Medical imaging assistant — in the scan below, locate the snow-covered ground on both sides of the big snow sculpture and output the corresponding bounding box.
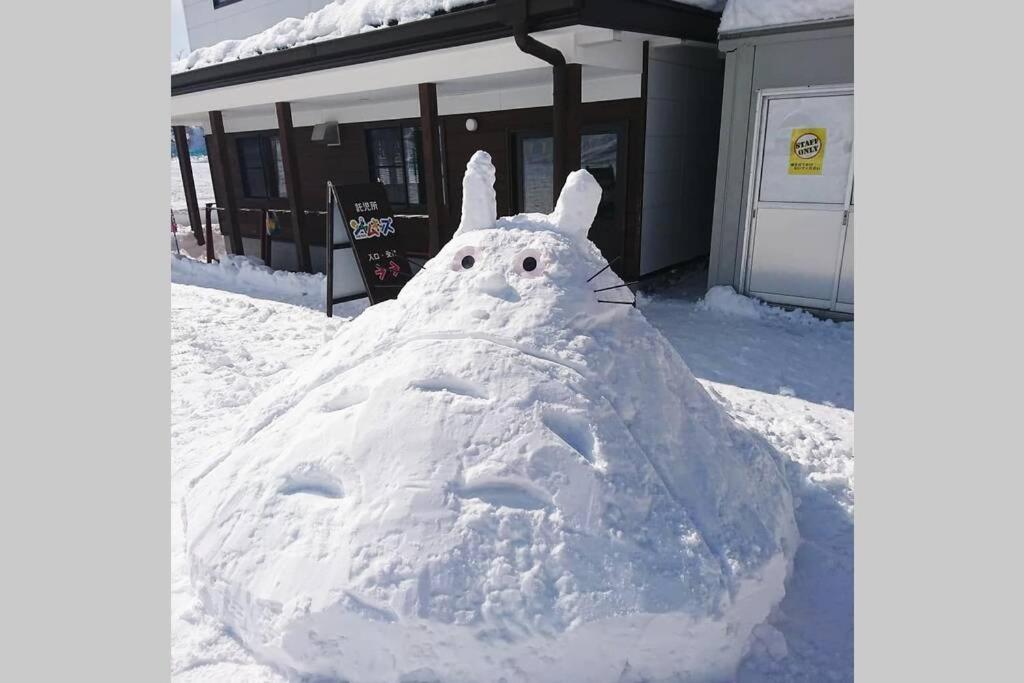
[171,257,854,682]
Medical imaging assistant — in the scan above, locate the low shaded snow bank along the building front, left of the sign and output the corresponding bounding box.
[171,252,326,308]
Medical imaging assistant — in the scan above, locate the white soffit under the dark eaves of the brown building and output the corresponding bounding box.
[171,26,655,118]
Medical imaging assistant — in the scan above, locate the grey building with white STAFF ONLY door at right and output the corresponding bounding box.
[708,6,854,315]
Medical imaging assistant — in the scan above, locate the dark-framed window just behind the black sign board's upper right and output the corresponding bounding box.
[367,126,423,208]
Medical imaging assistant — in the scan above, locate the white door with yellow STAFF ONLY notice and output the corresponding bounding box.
[745,87,853,312]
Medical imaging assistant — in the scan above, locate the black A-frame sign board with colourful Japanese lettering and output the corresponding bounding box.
[325,181,412,316]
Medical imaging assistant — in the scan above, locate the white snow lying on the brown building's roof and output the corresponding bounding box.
[171,0,725,74]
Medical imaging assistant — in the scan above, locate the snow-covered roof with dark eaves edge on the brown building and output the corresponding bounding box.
[171,0,722,96]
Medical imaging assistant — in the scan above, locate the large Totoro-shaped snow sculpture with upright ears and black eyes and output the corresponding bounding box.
[185,153,798,683]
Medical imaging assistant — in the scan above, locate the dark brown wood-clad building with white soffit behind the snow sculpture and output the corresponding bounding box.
[171,0,725,279]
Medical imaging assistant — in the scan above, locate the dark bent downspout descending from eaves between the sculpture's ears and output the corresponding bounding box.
[498,0,570,206]
